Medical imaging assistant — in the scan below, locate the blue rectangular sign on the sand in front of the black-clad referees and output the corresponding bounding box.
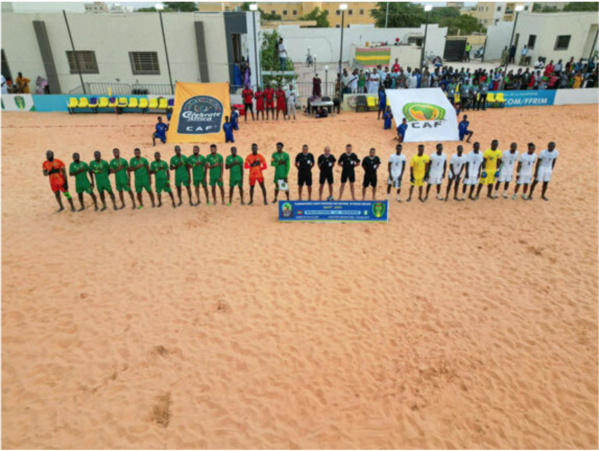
[279,200,389,222]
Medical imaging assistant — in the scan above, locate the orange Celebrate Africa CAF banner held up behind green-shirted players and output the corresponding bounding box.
[166,82,231,143]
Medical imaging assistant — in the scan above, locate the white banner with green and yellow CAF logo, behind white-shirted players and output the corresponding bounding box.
[385,88,460,142]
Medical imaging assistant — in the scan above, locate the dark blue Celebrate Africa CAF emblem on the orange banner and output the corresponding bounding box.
[177,96,224,135]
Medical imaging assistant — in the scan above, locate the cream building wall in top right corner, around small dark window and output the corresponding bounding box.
[514,13,599,62]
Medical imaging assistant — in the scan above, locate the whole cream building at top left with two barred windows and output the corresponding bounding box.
[1,12,260,94]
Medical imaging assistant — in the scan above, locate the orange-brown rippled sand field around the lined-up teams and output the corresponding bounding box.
[2,105,598,449]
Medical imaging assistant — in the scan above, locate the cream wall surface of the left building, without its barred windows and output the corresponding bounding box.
[2,13,248,93]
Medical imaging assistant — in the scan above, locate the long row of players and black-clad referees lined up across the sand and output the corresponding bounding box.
[43,140,558,211]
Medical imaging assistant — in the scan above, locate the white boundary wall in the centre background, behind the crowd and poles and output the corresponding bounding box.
[278,24,447,63]
